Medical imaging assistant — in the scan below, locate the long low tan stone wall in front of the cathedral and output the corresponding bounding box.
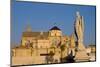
[12,48,67,65]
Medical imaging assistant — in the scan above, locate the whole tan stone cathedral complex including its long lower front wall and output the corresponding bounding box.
[12,26,73,65]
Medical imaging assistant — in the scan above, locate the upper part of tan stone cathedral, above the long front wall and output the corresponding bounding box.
[21,26,69,48]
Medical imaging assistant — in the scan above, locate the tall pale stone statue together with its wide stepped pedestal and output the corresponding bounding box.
[74,12,89,62]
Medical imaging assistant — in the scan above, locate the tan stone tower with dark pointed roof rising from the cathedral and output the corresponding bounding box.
[49,26,62,47]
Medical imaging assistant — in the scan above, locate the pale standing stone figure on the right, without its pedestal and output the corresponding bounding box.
[74,12,85,49]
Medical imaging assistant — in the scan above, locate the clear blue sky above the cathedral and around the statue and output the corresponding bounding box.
[11,1,96,45]
